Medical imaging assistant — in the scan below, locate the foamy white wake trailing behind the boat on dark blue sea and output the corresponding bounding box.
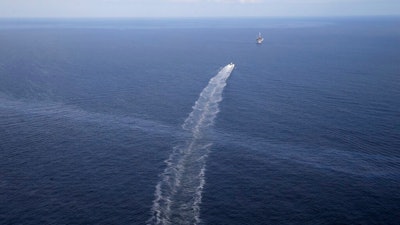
[147,63,235,225]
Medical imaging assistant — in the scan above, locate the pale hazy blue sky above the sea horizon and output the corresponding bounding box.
[0,0,400,17]
